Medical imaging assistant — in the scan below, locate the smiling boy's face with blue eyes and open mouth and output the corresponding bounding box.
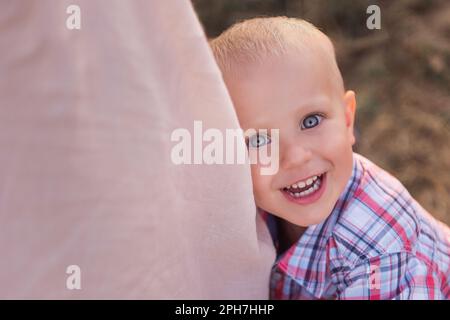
[225,49,355,226]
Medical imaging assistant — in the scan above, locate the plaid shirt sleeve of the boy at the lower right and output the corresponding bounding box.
[336,252,445,300]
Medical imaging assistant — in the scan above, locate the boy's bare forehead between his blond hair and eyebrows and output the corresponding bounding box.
[225,50,340,128]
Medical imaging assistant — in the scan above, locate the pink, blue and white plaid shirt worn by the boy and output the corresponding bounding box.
[261,153,450,300]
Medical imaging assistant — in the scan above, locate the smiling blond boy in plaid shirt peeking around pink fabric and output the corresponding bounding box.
[211,17,450,299]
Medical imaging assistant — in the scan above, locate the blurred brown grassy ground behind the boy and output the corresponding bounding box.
[192,0,450,225]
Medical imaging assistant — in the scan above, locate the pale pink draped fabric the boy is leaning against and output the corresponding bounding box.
[0,0,274,299]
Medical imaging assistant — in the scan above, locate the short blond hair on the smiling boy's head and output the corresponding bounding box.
[209,17,343,88]
